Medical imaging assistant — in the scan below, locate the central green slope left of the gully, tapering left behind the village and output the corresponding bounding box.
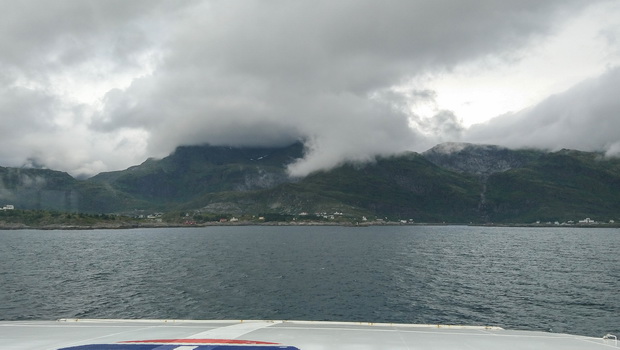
[185,153,479,222]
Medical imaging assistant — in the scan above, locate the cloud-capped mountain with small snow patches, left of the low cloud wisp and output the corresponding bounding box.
[89,143,303,207]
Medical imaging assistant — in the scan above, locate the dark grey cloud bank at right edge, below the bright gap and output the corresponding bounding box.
[465,68,620,155]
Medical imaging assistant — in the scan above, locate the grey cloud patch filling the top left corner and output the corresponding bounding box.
[0,0,179,73]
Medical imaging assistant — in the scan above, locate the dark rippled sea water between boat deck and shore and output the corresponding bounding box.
[0,226,620,337]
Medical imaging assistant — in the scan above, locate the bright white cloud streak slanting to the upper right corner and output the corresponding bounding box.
[409,1,620,126]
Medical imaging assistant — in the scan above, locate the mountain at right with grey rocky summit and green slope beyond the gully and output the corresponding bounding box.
[424,143,620,222]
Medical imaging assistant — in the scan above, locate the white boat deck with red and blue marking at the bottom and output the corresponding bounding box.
[0,319,620,350]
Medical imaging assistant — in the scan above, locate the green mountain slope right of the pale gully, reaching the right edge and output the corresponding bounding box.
[486,150,620,222]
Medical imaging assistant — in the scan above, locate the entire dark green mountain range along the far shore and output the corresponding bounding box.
[0,143,620,223]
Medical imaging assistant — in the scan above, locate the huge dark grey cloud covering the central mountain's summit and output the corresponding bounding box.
[92,1,592,175]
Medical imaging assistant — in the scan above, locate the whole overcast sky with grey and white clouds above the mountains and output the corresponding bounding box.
[0,0,620,177]
